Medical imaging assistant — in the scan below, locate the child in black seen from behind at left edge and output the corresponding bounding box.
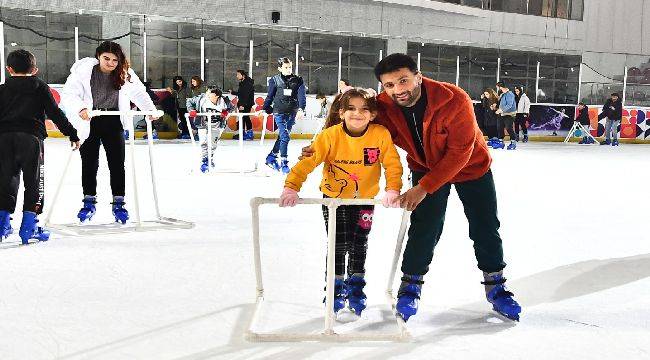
[0,49,79,244]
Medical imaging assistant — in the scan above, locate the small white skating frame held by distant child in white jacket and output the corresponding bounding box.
[185,112,269,174]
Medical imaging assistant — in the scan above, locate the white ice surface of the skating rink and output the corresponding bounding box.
[0,139,650,360]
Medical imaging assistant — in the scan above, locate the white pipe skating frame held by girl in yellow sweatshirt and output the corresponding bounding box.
[245,197,411,342]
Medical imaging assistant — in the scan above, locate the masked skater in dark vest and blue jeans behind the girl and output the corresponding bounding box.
[263,57,307,174]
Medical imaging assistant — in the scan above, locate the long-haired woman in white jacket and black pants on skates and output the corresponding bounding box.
[60,41,156,224]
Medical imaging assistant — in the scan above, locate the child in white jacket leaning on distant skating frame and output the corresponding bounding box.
[187,85,233,172]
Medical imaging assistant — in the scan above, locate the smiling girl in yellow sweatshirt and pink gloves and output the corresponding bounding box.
[280,88,402,315]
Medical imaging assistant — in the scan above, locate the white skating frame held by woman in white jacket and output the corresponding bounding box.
[44,110,194,235]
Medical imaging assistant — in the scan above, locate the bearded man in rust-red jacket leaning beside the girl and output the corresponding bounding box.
[303,53,521,320]
